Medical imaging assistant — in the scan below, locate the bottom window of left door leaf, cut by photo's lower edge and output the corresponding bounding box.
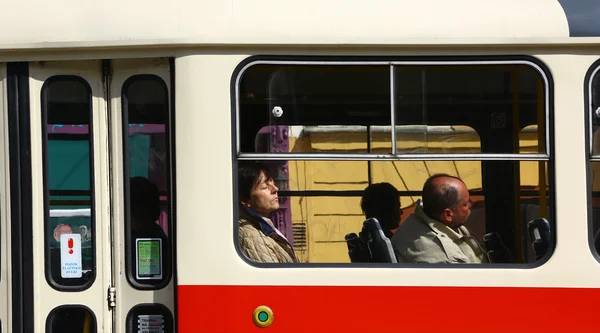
[46,305,96,333]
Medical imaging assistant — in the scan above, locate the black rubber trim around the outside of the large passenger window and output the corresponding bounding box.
[230,55,558,269]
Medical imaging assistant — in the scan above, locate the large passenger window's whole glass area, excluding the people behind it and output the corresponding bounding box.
[236,62,555,264]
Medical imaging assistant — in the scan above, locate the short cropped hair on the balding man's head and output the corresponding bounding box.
[423,173,462,219]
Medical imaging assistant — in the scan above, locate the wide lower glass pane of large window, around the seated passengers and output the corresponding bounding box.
[238,161,551,263]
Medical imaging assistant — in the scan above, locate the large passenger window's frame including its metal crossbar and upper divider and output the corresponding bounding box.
[230,55,556,269]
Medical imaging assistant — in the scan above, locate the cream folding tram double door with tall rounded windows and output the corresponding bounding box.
[29,59,174,333]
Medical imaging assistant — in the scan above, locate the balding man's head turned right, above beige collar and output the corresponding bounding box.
[423,174,472,228]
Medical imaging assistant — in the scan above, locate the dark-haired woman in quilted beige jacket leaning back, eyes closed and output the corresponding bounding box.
[238,162,298,263]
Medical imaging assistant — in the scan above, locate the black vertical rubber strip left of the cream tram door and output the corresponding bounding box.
[7,62,34,333]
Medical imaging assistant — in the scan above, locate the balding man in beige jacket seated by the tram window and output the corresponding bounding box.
[392,174,484,263]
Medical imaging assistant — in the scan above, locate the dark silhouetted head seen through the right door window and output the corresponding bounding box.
[129,177,160,222]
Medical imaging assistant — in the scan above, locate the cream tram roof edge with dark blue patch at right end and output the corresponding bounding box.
[0,0,600,51]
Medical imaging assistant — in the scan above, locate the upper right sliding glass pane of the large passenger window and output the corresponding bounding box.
[395,65,545,154]
